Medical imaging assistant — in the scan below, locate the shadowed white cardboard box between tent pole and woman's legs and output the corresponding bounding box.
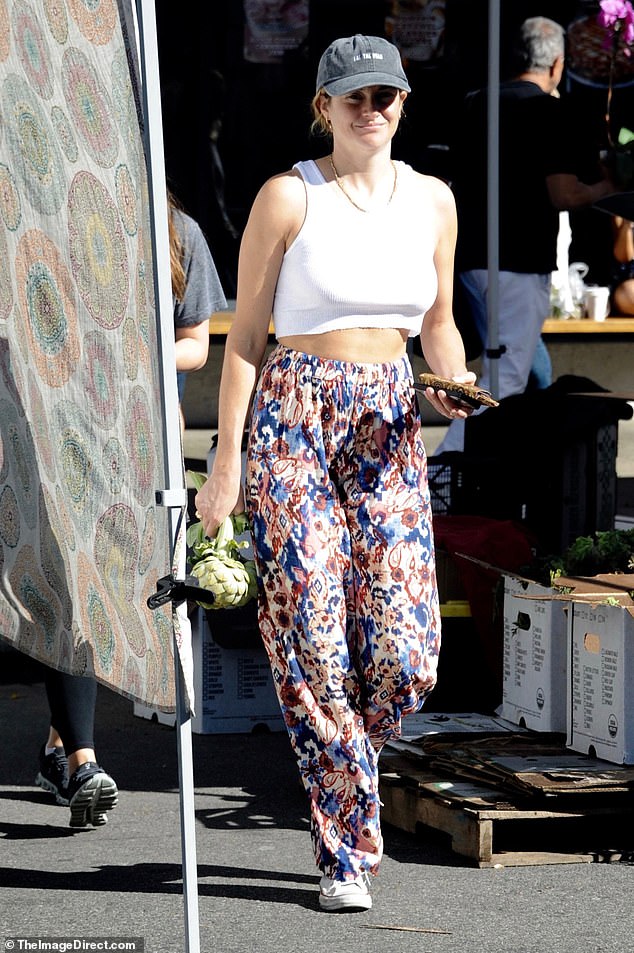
[134,610,286,734]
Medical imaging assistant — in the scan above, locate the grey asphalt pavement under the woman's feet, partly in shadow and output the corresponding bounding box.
[0,652,634,953]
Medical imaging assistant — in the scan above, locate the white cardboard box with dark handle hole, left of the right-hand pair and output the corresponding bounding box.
[500,575,570,734]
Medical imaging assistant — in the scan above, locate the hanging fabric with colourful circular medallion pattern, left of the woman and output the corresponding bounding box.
[0,0,174,708]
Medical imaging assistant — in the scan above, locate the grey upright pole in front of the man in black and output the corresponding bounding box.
[487,0,500,397]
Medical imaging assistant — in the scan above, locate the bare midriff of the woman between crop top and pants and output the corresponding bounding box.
[279,328,407,364]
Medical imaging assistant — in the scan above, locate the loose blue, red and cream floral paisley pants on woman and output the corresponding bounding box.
[247,345,440,880]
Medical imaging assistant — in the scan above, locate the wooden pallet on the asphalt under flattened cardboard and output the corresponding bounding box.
[380,765,634,867]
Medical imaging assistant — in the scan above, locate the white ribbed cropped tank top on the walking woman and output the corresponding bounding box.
[273,159,438,338]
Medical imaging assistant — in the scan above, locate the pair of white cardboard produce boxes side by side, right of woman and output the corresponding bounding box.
[501,574,634,764]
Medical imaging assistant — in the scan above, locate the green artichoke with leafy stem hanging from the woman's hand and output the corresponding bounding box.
[187,473,258,609]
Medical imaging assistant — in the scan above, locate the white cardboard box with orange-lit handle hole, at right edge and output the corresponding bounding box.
[567,594,634,764]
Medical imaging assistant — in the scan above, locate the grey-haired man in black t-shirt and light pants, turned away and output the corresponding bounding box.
[437,17,614,453]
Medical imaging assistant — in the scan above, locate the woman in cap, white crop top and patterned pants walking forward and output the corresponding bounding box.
[196,35,474,911]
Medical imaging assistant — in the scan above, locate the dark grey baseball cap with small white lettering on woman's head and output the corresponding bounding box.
[317,33,411,96]
